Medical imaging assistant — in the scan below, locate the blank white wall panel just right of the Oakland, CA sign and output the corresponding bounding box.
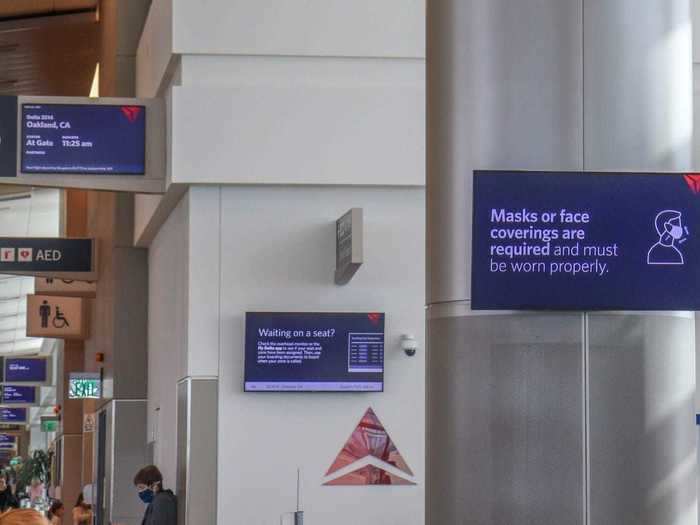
[171,86,425,185]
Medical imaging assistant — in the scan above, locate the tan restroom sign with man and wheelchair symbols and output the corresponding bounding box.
[27,295,88,339]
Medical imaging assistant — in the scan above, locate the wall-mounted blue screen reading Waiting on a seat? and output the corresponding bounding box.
[244,312,384,392]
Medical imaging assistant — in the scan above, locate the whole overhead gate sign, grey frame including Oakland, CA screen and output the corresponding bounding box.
[0,96,165,193]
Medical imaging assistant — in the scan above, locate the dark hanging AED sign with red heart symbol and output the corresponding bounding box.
[0,237,95,277]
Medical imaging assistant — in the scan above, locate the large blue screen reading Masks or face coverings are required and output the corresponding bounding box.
[471,171,700,310]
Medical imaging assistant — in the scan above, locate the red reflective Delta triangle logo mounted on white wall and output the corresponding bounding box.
[324,408,415,485]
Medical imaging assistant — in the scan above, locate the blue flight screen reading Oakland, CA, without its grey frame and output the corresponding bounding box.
[21,104,146,175]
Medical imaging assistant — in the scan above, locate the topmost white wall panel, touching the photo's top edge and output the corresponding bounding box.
[174,0,425,57]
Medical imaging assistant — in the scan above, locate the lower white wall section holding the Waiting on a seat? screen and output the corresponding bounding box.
[213,187,425,525]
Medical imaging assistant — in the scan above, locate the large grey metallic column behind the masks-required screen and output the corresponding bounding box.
[427,0,697,525]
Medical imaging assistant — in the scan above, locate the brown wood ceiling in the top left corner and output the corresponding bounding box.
[0,0,100,96]
